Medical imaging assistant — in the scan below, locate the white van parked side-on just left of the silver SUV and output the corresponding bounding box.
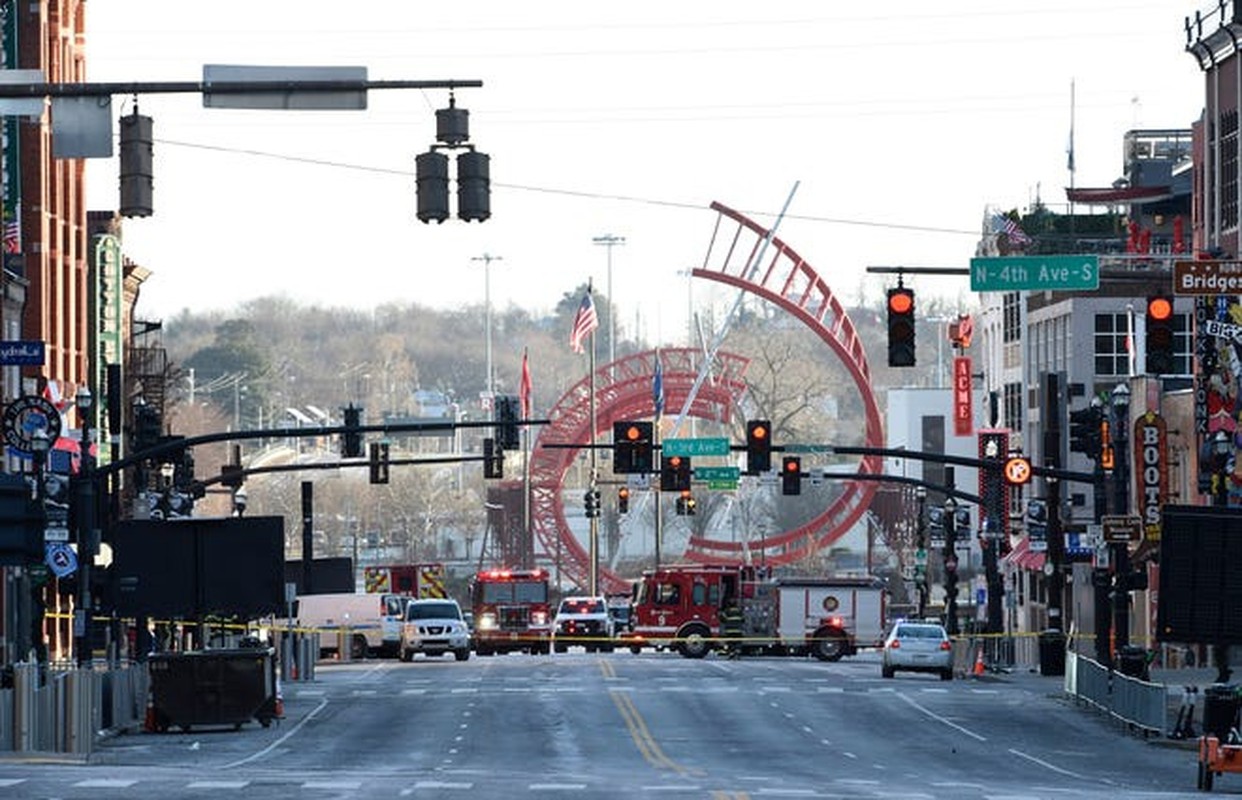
[293,593,410,658]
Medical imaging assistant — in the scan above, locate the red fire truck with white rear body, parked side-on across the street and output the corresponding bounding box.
[621,564,886,661]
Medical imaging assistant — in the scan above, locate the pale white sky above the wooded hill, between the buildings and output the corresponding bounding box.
[80,0,1211,344]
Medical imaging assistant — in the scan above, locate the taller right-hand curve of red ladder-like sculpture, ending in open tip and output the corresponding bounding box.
[687,202,884,564]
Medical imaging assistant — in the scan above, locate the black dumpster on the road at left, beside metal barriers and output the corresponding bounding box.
[147,647,279,733]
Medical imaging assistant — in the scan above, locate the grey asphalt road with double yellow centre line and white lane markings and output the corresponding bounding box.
[0,652,1212,800]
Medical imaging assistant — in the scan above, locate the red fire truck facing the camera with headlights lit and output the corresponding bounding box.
[469,569,551,656]
